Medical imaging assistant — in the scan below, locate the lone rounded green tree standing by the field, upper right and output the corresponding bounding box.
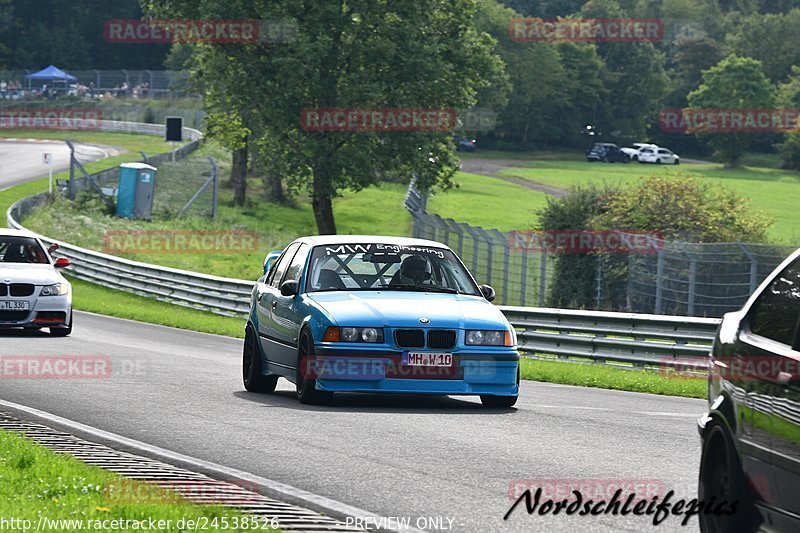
[688,55,774,167]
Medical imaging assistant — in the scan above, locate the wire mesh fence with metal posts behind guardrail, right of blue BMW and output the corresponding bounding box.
[404,181,796,317]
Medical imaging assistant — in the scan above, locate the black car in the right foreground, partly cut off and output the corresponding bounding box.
[698,250,800,533]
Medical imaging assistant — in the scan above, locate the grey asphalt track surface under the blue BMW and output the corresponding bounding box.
[0,313,705,532]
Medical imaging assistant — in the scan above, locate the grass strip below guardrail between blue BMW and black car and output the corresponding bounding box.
[521,358,708,398]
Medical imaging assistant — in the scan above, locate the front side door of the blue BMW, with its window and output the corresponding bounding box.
[271,244,310,367]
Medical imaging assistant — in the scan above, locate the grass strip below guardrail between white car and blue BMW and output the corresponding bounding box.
[69,278,245,338]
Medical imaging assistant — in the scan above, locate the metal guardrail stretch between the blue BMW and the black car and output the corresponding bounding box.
[500,307,720,370]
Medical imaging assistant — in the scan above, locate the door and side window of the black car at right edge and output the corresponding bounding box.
[740,259,800,515]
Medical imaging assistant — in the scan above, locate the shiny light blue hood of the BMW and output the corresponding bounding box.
[307,291,509,329]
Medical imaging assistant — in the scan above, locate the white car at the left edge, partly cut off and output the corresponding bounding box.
[0,229,72,337]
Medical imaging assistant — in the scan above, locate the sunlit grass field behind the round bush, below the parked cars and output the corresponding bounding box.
[502,160,800,245]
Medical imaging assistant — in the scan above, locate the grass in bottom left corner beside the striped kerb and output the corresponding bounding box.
[0,431,272,532]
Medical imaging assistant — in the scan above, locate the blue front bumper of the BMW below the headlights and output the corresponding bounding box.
[306,346,519,396]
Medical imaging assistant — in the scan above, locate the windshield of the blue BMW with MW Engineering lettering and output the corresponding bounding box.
[306,243,480,296]
